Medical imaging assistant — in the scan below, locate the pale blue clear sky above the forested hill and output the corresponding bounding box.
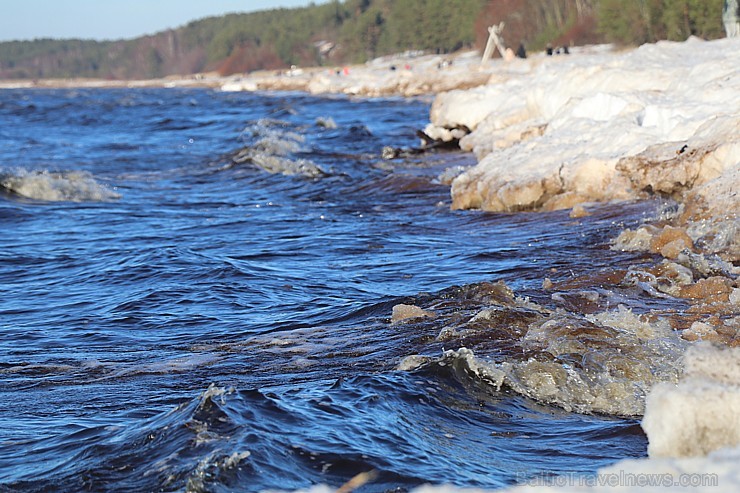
[0,0,325,41]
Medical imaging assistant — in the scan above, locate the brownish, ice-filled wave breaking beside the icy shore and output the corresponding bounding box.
[399,283,686,416]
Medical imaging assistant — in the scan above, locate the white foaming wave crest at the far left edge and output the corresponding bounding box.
[0,169,121,202]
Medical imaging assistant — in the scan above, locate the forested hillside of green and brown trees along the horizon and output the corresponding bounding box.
[0,0,723,79]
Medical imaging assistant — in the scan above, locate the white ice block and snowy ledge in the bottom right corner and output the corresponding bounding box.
[486,343,740,493]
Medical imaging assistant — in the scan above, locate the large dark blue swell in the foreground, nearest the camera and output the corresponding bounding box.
[0,367,642,492]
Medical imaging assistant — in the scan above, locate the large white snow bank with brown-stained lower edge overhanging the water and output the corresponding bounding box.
[427,39,740,211]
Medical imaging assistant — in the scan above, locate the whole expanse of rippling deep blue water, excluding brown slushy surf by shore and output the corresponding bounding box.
[0,89,646,491]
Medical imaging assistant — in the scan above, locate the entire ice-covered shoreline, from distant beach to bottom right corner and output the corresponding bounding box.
[7,38,740,493]
